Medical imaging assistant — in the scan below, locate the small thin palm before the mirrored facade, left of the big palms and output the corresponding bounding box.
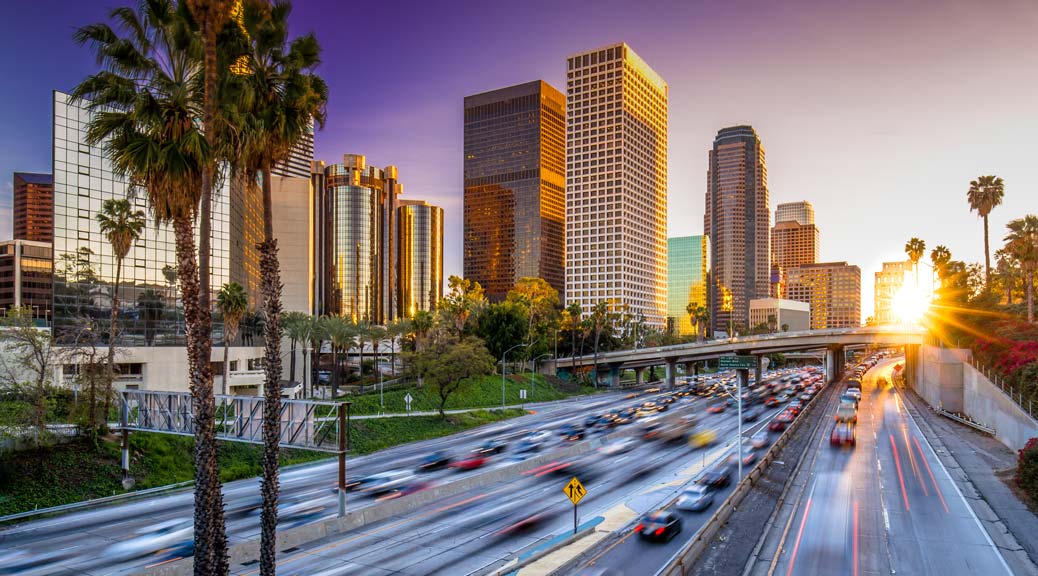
[97,198,144,421]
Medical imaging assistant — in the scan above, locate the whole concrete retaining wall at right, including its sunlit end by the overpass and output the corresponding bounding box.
[912,346,1038,450]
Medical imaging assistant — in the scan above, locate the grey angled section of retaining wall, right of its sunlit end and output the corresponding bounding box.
[962,364,1038,450]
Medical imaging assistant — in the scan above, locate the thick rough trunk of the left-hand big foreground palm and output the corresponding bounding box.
[173,218,229,576]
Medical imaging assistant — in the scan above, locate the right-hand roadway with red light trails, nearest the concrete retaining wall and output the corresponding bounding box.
[776,360,1010,576]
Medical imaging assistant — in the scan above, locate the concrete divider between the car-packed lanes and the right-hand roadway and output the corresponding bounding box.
[656,381,839,576]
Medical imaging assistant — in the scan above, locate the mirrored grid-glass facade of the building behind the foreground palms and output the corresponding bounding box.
[53,91,249,347]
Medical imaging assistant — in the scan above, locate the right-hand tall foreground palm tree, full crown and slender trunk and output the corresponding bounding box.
[234,0,328,574]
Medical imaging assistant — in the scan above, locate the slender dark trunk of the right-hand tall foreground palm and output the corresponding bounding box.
[260,161,281,576]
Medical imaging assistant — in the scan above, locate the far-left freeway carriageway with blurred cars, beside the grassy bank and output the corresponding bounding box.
[0,393,640,574]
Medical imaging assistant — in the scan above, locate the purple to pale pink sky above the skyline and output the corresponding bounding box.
[0,0,1038,320]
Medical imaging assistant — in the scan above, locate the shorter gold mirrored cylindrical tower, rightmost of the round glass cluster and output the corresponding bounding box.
[397,200,443,318]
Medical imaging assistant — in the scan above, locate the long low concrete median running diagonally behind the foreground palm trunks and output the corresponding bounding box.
[142,427,637,576]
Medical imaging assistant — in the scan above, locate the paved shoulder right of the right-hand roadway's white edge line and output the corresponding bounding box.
[898,386,1038,575]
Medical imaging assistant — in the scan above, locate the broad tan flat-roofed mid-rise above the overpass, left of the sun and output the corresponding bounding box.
[786,262,862,330]
